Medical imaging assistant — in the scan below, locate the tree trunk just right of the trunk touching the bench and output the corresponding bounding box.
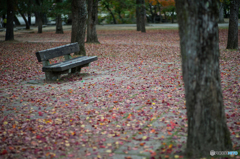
[87,0,99,43]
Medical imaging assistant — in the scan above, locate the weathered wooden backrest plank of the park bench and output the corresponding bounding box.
[36,42,79,62]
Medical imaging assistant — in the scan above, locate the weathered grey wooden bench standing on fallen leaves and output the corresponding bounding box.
[36,42,97,81]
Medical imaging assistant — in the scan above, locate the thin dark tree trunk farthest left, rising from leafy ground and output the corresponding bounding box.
[5,0,15,41]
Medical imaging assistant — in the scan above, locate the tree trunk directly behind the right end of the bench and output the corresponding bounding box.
[71,0,87,56]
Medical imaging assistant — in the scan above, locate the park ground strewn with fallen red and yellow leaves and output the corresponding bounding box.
[0,30,240,159]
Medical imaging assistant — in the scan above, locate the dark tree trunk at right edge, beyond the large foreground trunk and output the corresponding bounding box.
[227,0,240,49]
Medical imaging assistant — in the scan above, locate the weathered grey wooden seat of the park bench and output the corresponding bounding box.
[42,56,97,72]
